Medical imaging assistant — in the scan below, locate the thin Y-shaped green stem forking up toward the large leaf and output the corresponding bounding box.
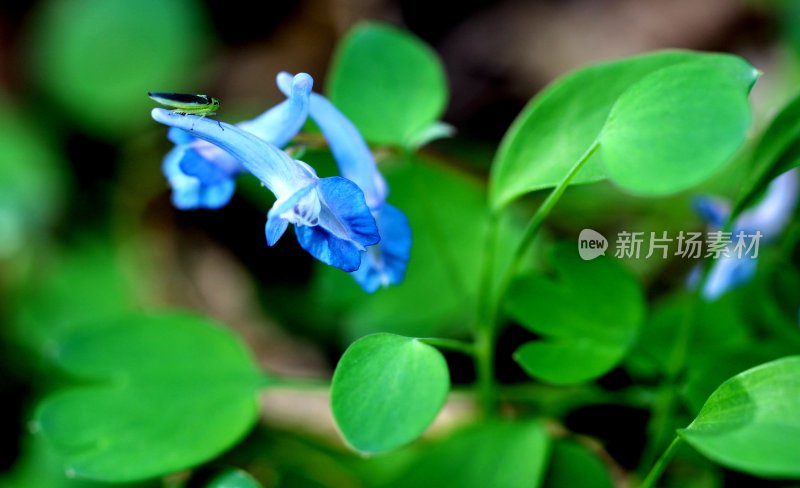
[475,141,600,415]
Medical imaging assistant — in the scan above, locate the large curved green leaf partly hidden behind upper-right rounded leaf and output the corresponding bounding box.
[490,51,756,209]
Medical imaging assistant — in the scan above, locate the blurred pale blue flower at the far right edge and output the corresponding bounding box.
[690,170,798,300]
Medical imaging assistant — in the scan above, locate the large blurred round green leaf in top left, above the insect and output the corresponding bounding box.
[28,0,208,137]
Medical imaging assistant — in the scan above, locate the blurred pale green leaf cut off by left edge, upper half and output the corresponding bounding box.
[0,99,68,259]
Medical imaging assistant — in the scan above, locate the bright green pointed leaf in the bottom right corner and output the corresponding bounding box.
[679,356,800,478]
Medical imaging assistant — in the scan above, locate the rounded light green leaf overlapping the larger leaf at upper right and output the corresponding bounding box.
[598,62,757,195]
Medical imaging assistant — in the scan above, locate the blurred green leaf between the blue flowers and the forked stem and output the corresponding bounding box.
[310,154,519,340]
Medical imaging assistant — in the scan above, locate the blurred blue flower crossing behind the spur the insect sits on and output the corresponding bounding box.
[162,73,313,210]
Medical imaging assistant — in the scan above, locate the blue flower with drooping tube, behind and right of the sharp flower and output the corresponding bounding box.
[278,73,411,293]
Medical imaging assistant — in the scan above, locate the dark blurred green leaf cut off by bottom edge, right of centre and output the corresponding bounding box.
[544,440,614,488]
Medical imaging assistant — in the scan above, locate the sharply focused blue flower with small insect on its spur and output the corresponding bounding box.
[152,108,380,272]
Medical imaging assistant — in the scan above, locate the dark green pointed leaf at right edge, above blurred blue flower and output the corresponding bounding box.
[731,93,800,219]
